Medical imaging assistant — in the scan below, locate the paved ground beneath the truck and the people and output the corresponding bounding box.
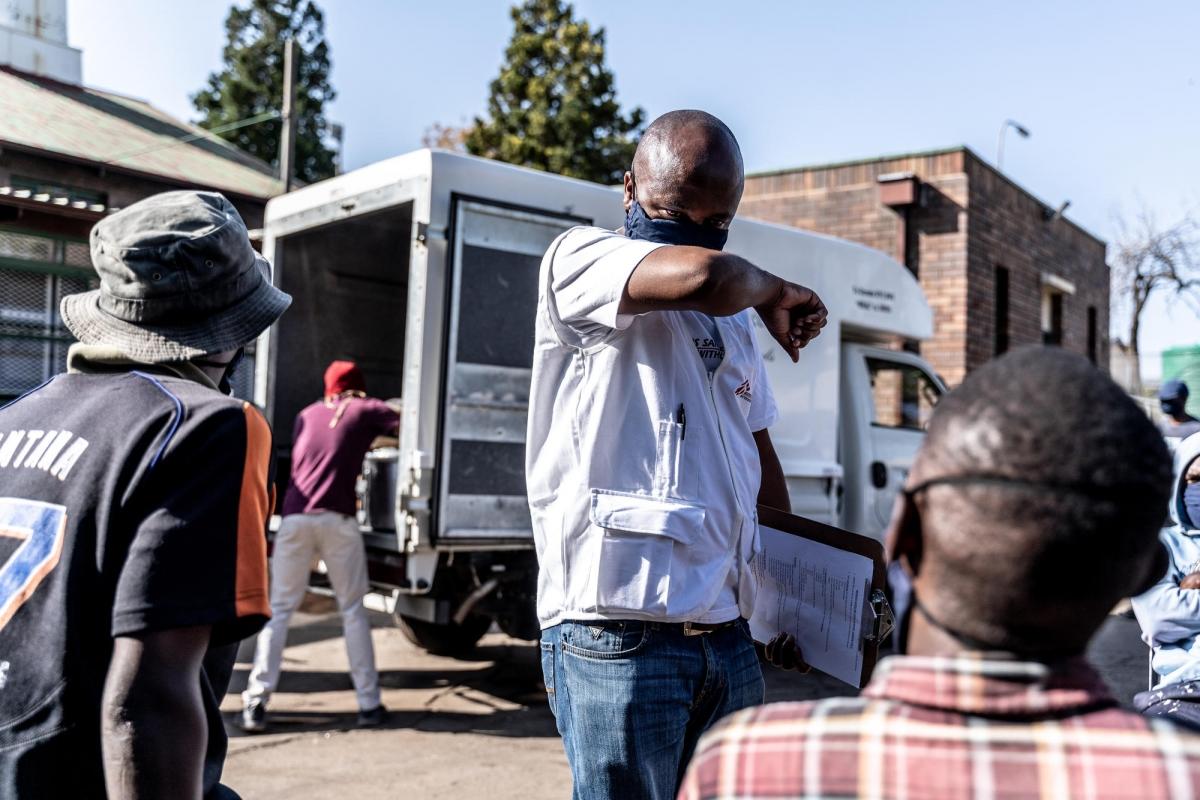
[222,601,1146,800]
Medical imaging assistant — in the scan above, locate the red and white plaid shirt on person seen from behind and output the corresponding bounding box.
[679,654,1200,800]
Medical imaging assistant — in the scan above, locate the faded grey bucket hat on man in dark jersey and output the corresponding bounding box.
[61,192,292,363]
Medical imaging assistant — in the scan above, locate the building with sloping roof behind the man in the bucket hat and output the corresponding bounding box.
[0,10,282,402]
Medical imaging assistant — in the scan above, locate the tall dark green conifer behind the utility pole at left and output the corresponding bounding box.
[192,0,335,184]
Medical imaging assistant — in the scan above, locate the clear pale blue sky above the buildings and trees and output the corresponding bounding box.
[68,0,1200,377]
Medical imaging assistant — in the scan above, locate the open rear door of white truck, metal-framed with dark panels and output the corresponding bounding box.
[434,198,582,546]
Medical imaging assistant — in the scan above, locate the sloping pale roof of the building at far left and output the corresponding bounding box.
[0,68,283,198]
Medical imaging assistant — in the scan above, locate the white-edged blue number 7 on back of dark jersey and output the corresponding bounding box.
[0,498,67,628]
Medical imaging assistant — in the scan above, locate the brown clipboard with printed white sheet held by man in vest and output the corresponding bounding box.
[751,506,895,687]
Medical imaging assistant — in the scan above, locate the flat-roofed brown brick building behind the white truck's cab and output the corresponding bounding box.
[739,148,1109,385]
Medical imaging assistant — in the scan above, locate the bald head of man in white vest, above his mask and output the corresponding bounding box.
[625,110,745,228]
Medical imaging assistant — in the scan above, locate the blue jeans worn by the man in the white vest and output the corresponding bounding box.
[541,620,764,800]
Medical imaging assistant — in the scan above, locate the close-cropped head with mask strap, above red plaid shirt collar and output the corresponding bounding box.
[894,348,1171,655]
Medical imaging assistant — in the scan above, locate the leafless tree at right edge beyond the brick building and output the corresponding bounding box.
[1109,205,1200,390]
